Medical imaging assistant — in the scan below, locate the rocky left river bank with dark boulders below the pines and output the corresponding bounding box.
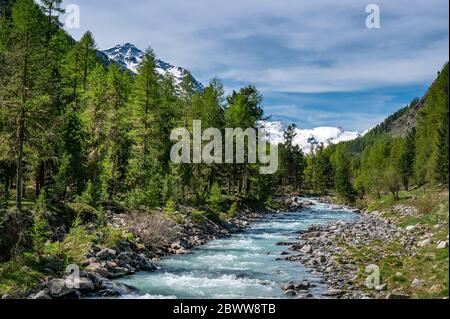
[22,202,268,299]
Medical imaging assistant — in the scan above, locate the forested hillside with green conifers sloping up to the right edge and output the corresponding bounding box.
[309,64,449,200]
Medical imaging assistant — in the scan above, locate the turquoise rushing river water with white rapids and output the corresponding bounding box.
[119,202,356,299]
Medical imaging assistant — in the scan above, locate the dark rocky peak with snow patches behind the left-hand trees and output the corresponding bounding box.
[101,43,204,91]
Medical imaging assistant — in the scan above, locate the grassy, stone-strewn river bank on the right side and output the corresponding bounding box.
[284,193,449,299]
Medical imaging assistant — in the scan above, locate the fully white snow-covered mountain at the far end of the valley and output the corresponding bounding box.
[259,121,362,154]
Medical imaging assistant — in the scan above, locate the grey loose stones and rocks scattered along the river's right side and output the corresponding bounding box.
[279,199,448,299]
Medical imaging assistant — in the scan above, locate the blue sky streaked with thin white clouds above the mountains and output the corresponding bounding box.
[59,0,449,131]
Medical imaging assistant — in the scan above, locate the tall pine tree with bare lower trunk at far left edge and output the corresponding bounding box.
[3,0,48,210]
